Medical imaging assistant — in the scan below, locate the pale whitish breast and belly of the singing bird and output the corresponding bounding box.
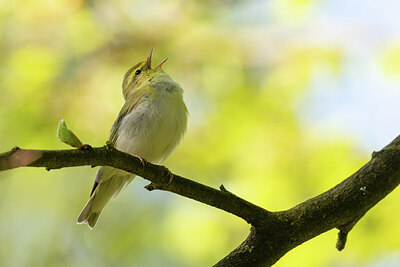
[116,83,187,163]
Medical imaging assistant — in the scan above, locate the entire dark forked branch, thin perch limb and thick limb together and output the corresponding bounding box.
[0,136,400,266]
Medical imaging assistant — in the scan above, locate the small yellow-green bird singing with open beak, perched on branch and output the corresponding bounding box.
[77,50,188,229]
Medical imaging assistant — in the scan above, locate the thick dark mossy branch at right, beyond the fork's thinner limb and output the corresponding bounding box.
[216,136,400,266]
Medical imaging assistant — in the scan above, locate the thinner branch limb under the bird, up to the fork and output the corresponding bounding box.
[0,146,269,225]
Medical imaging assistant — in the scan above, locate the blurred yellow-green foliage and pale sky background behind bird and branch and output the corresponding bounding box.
[0,0,400,267]
